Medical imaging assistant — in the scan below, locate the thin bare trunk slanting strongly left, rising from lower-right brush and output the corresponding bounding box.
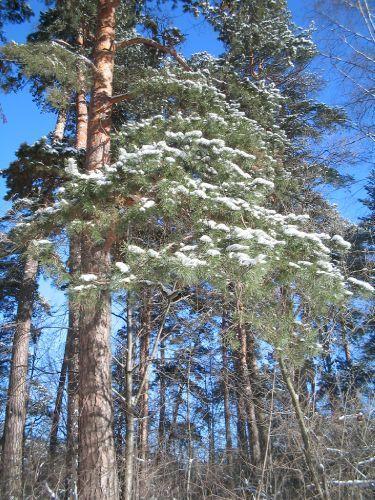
[278,357,330,500]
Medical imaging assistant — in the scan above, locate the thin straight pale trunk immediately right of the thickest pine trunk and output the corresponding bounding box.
[123,295,134,500]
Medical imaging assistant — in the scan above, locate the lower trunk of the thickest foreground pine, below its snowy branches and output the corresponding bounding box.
[78,239,118,500]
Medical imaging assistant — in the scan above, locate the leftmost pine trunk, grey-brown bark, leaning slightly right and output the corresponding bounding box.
[1,255,38,499]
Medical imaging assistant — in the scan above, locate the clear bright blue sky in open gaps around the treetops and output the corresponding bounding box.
[0,0,369,220]
